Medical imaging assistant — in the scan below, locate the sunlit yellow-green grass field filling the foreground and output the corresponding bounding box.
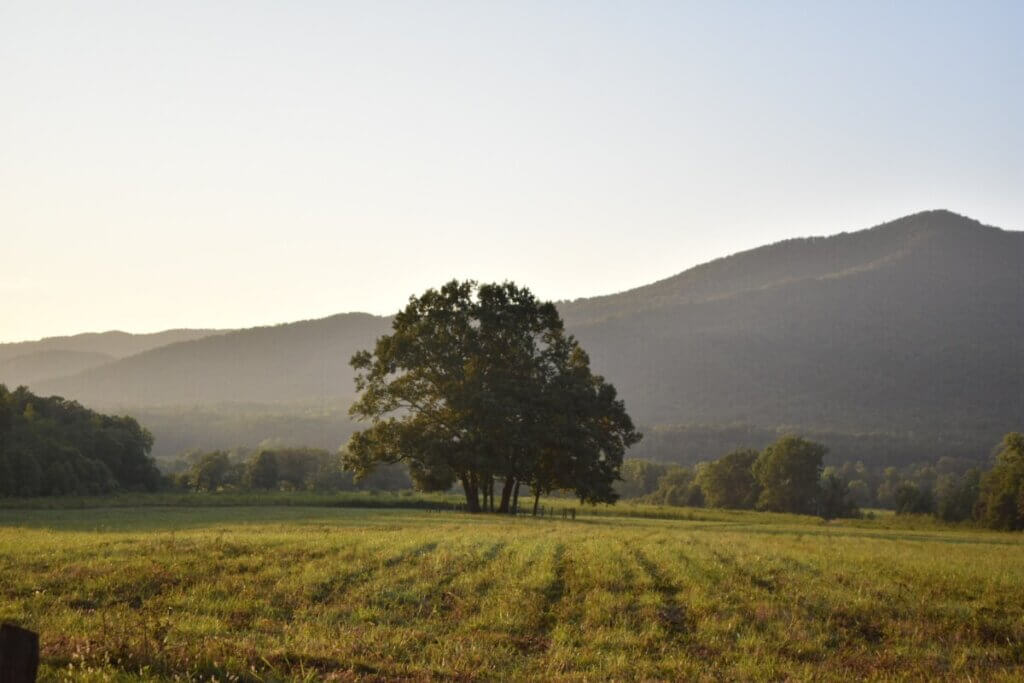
[0,506,1024,680]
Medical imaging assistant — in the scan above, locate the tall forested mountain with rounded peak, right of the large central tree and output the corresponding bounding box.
[562,211,1024,434]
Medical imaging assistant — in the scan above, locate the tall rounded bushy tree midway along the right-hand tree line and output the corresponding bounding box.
[754,436,826,514]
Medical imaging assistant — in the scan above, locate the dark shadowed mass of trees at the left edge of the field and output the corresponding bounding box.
[0,384,161,496]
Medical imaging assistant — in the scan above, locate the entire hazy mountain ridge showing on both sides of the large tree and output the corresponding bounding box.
[16,211,1024,460]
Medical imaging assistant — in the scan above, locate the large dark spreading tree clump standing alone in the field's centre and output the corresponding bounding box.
[345,281,640,512]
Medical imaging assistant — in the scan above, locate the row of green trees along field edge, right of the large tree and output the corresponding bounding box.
[617,432,1024,529]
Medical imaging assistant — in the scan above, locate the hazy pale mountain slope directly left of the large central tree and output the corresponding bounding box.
[38,313,390,408]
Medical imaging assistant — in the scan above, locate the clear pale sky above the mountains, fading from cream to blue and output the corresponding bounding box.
[0,0,1024,342]
